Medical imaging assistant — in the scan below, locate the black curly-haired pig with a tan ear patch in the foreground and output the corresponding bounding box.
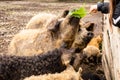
[0,48,74,80]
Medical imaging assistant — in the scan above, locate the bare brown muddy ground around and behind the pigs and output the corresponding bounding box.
[0,1,104,80]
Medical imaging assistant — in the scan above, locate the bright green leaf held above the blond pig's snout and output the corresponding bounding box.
[70,7,87,18]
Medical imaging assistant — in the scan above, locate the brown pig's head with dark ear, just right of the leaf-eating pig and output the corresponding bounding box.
[72,23,94,52]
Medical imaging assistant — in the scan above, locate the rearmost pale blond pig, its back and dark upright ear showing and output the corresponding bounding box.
[26,10,69,29]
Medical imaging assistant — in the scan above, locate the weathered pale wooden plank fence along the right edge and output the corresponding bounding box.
[102,0,120,80]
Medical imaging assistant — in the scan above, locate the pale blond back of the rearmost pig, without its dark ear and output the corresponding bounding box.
[26,12,57,29]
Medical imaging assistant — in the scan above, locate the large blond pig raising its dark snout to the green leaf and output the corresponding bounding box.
[8,15,80,56]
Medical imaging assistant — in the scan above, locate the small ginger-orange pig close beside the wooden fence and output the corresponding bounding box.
[83,35,102,63]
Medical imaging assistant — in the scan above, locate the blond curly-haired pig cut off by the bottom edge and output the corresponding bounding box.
[24,65,83,80]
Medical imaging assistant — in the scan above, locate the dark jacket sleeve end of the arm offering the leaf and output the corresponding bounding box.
[97,2,109,14]
